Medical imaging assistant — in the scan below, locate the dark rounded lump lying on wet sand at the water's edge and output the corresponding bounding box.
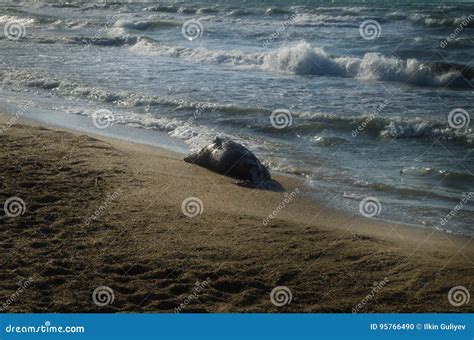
[184,137,277,189]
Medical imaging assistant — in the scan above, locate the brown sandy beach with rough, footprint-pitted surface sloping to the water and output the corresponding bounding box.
[0,115,474,313]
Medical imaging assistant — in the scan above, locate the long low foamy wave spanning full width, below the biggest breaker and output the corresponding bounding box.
[0,66,474,147]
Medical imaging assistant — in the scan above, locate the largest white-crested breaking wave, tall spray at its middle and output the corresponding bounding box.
[125,40,474,88]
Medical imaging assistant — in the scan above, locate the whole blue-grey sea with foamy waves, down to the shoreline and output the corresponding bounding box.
[0,1,474,235]
